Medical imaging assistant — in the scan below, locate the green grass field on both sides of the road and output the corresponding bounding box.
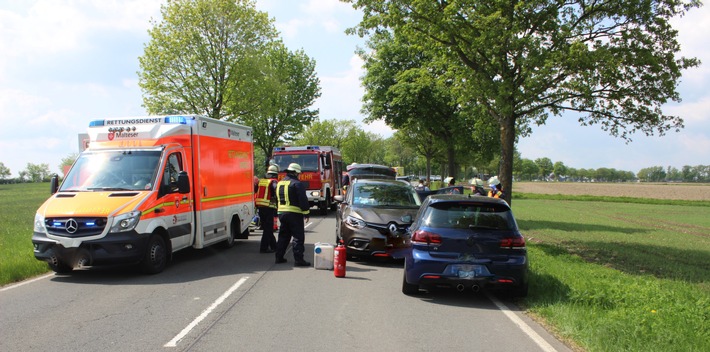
[0,183,710,352]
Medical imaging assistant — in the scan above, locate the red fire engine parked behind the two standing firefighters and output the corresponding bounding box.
[272,145,344,214]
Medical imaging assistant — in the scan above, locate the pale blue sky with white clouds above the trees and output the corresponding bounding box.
[0,0,710,177]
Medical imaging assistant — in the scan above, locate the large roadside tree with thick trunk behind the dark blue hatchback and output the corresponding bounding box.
[343,0,700,202]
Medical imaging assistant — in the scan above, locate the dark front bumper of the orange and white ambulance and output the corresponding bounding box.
[32,231,149,266]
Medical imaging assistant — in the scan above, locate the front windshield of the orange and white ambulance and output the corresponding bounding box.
[59,150,160,192]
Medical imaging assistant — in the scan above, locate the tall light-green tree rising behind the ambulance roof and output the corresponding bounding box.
[138,0,276,120]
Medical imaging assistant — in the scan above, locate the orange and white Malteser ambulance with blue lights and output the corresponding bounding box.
[32,116,254,274]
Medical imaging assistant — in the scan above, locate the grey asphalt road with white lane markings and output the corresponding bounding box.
[0,213,569,352]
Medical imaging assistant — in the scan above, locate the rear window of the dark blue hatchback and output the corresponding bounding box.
[422,202,515,230]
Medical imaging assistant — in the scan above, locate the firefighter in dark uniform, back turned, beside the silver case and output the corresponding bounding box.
[276,163,311,266]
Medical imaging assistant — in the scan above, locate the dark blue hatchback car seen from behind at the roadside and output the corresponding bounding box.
[402,194,528,296]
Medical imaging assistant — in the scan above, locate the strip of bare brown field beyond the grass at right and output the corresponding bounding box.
[513,182,710,200]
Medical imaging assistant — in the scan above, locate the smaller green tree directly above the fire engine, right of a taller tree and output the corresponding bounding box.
[242,41,320,166]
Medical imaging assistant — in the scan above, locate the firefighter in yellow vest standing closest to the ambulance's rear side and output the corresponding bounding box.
[256,165,279,253]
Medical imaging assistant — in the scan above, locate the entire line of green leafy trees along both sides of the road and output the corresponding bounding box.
[4,0,700,202]
